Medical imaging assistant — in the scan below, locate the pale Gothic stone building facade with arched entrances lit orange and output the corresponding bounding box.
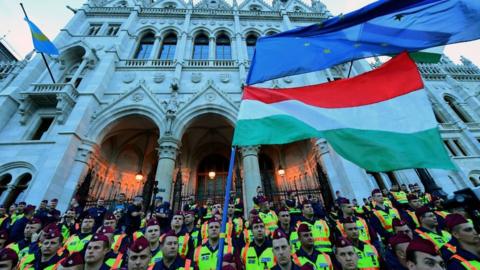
[0,0,480,212]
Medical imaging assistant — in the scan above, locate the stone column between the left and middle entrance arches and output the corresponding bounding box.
[155,137,179,203]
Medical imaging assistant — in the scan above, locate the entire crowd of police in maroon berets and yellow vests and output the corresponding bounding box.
[0,182,480,270]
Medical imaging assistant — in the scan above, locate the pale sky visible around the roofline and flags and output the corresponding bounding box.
[0,0,480,66]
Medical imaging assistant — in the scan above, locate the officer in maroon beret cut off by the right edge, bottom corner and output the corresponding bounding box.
[445,214,480,270]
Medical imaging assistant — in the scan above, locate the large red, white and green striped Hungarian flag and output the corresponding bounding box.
[233,53,456,172]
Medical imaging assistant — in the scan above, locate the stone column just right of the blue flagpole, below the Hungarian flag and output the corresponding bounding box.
[240,146,262,213]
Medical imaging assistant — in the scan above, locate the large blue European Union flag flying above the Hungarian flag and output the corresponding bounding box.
[247,0,480,85]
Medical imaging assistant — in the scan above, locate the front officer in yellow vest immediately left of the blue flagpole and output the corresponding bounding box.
[193,218,234,270]
